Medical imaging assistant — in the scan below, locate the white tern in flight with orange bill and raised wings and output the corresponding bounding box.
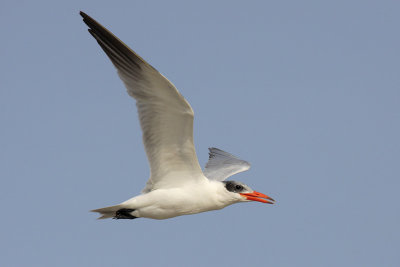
[80,11,275,220]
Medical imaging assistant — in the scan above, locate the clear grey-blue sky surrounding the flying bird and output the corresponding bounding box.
[0,0,400,267]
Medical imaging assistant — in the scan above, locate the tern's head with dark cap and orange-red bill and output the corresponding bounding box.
[223,181,275,204]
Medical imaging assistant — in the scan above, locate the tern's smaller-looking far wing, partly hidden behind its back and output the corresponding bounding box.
[203,147,250,181]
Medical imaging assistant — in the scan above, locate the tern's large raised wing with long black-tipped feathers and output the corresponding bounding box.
[80,12,204,192]
